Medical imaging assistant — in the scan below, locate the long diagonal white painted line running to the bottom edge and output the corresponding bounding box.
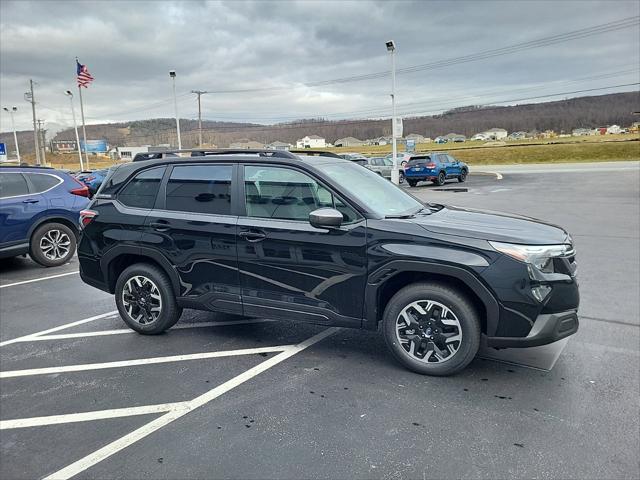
[45,327,339,480]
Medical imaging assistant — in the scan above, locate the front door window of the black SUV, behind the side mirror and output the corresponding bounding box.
[244,166,358,223]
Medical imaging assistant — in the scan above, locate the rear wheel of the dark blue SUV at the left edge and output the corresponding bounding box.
[29,222,76,267]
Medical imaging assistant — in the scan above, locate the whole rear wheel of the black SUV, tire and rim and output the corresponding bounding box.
[115,263,182,335]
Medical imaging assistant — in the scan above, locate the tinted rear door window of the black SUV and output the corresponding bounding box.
[166,165,231,215]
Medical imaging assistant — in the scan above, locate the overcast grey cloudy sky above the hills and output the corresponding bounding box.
[0,0,640,131]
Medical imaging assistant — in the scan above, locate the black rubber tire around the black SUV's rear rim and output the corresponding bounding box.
[115,263,182,335]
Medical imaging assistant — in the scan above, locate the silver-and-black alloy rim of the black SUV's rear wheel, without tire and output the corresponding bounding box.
[122,275,162,325]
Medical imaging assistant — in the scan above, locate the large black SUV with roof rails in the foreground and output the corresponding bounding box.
[78,151,579,375]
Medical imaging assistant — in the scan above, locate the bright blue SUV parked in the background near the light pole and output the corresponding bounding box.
[404,153,469,187]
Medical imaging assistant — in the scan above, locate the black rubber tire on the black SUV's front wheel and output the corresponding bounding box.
[382,282,480,376]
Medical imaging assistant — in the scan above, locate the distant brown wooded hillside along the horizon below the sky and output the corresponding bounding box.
[0,92,640,153]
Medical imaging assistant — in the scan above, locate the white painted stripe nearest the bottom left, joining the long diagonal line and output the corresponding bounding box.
[0,402,187,430]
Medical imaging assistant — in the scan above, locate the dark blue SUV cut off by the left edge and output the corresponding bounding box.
[0,167,89,267]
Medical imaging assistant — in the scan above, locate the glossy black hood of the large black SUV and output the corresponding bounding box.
[411,206,570,245]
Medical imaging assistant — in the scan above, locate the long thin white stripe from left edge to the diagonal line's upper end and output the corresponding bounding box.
[0,345,291,379]
